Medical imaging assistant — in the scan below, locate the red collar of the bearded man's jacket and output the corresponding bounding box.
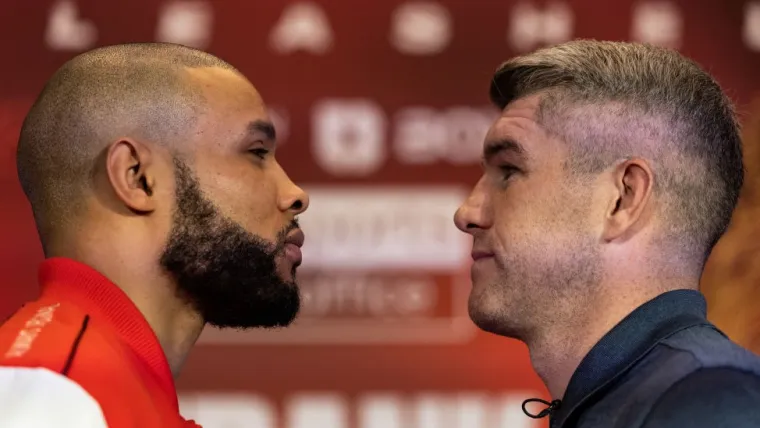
[39,257,179,409]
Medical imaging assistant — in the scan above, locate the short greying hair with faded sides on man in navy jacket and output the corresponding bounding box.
[490,40,744,263]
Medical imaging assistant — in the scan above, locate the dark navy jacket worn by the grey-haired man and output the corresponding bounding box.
[550,290,760,428]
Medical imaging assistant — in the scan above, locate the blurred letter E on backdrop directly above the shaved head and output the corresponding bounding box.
[156,0,214,49]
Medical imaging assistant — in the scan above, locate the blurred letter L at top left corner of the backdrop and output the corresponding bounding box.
[45,0,98,51]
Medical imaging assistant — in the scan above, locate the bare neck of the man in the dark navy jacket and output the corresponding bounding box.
[527,286,692,399]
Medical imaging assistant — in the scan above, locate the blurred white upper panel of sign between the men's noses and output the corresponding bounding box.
[299,185,471,272]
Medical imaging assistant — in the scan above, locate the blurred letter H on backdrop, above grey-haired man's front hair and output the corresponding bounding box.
[507,1,574,52]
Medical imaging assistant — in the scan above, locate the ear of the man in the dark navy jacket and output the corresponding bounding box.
[602,158,654,242]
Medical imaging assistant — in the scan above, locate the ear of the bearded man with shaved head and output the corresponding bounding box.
[106,138,156,214]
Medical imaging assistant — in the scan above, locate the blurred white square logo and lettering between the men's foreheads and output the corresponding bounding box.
[310,98,499,176]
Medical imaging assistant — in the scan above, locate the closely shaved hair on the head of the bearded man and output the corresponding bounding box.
[17,43,235,247]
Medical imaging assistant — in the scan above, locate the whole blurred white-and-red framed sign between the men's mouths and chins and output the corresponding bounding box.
[200,186,476,345]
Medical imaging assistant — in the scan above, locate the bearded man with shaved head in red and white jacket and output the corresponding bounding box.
[0,43,308,428]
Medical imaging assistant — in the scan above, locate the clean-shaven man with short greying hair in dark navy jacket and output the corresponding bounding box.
[455,40,760,428]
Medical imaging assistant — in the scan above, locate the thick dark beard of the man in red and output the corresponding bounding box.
[160,158,301,328]
